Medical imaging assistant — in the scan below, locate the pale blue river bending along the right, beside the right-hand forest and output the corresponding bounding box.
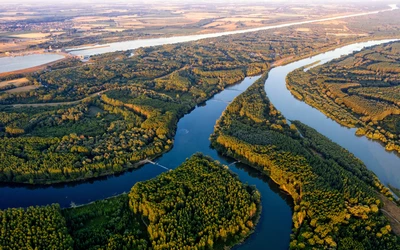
[265,40,400,188]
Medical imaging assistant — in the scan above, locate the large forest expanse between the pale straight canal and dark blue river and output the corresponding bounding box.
[0,22,368,184]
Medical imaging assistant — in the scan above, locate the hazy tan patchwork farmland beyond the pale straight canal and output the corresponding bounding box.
[0,1,387,55]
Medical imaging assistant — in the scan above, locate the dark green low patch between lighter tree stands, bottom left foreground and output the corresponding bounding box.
[62,194,149,250]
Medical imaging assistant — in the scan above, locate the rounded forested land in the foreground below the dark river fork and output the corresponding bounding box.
[0,154,261,250]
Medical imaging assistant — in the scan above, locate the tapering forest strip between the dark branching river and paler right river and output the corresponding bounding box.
[211,75,400,249]
